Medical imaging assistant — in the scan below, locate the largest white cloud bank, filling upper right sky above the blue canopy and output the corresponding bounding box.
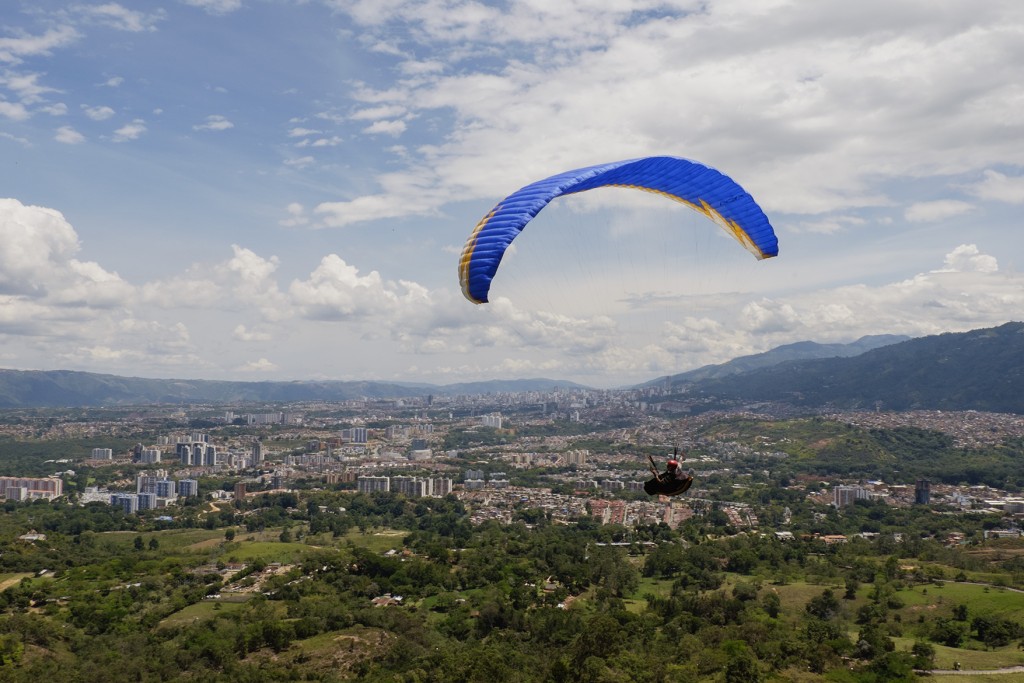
[309,0,1024,229]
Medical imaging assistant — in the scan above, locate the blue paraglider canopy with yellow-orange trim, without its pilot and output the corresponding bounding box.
[459,157,778,303]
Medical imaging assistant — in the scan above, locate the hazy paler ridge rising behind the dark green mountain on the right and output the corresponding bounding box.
[640,335,910,387]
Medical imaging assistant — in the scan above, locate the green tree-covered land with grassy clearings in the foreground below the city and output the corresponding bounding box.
[0,486,1024,683]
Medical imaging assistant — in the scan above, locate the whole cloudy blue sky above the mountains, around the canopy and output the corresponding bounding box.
[0,0,1024,388]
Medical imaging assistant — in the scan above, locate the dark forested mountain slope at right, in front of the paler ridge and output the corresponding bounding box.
[675,323,1024,414]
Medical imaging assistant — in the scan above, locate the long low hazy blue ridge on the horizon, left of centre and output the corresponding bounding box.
[0,370,586,409]
